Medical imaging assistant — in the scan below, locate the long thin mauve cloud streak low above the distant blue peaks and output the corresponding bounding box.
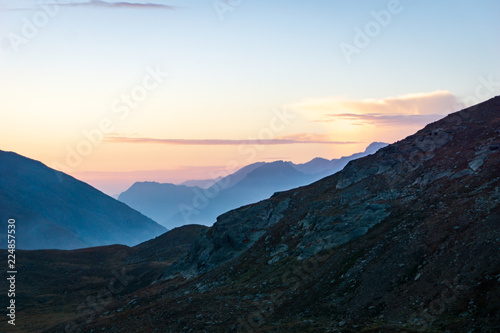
[104,133,358,146]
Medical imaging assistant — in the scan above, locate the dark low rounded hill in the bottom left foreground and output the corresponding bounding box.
[0,225,207,332]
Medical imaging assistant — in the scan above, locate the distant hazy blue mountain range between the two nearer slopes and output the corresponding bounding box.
[118,142,387,228]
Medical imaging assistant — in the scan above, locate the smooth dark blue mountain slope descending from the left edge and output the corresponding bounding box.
[0,151,166,249]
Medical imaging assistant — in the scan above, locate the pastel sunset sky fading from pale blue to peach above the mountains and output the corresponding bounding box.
[0,0,500,195]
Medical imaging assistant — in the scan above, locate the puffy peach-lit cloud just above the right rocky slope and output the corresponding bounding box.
[291,91,458,125]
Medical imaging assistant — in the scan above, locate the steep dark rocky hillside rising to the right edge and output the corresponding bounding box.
[59,97,500,332]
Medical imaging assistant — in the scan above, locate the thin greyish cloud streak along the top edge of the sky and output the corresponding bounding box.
[6,0,178,10]
